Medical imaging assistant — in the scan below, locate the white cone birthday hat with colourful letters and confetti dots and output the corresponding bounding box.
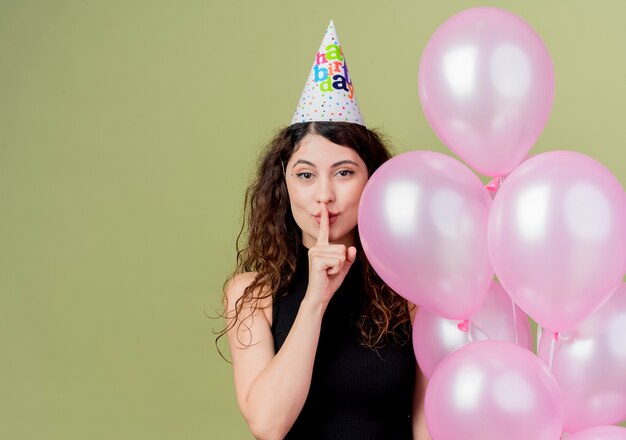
[291,20,365,125]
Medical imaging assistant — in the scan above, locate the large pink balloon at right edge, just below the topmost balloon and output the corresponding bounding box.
[488,151,626,331]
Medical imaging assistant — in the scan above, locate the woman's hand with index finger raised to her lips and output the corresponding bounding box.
[305,203,356,306]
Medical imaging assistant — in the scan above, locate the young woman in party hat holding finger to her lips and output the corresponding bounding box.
[217,22,429,440]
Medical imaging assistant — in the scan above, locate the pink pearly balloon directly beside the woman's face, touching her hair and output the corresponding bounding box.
[359,151,493,319]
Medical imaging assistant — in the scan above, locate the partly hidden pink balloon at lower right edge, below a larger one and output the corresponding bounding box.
[538,283,626,432]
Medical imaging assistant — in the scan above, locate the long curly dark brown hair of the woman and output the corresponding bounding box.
[217,122,410,349]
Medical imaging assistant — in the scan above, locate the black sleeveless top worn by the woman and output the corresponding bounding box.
[272,246,416,440]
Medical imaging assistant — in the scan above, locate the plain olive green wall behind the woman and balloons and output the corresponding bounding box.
[0,0,626,440]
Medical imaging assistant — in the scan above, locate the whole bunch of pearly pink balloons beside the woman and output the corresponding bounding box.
[359,7,626,440]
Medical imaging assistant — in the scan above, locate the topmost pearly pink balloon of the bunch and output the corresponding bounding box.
[418,7,554,176]
